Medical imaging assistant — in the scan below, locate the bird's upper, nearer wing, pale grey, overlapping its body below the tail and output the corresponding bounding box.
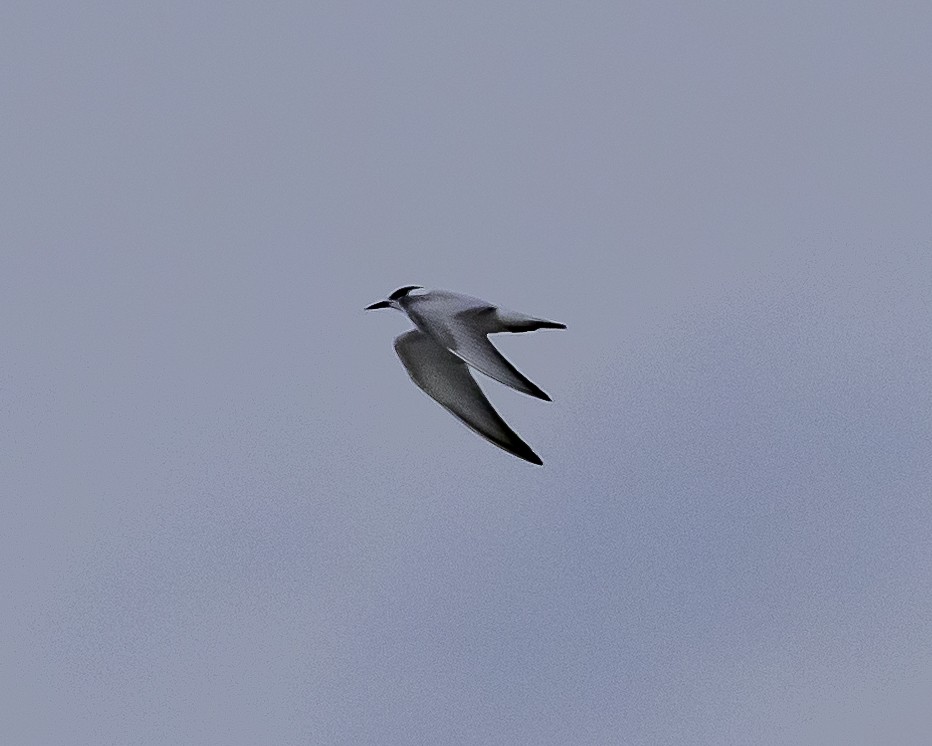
[408,305,550,401]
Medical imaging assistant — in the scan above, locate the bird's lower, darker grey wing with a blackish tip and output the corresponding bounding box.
[395,329,543,465]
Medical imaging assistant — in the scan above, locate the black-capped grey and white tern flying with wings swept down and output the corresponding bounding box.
[365,285,566,466]
